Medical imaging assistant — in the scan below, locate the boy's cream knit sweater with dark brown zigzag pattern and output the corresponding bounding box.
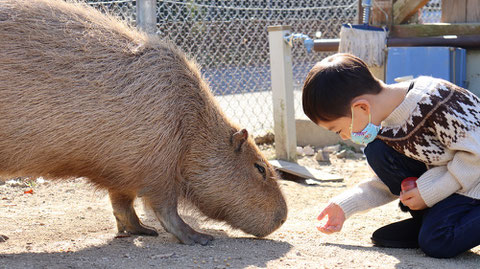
[331,77,480,218]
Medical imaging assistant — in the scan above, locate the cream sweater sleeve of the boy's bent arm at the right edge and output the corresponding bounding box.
[417,133,480,207]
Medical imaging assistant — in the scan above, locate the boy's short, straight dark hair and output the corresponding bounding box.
[302,53,382,123]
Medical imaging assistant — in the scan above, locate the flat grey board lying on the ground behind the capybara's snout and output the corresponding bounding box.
[269,160,343,182]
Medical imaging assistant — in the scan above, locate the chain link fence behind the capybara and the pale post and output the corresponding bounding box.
[87,0,440,135]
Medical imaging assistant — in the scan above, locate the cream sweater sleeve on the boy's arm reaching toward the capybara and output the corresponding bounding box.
[330,178,398,218]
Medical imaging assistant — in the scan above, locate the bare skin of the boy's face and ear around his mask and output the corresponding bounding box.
[317,104,369,140]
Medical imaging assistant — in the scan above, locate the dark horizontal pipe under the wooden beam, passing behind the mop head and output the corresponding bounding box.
[313,35,480,51]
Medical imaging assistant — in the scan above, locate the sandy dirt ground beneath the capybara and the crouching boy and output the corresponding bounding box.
[0,147,480,269]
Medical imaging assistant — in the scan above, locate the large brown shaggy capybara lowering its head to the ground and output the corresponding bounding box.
[0,0,287,245]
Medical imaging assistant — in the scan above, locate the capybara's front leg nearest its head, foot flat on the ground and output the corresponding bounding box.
[150,198,213,246]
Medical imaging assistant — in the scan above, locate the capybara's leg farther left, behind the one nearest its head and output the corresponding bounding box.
[108,190,158,236]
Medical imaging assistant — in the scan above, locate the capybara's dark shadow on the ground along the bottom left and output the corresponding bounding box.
[0,230,292,268]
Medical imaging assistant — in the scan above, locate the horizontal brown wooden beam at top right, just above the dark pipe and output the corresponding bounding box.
[389,23,480,37]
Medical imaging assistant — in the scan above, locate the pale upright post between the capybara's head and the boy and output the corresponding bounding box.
[268,26,297,161]
